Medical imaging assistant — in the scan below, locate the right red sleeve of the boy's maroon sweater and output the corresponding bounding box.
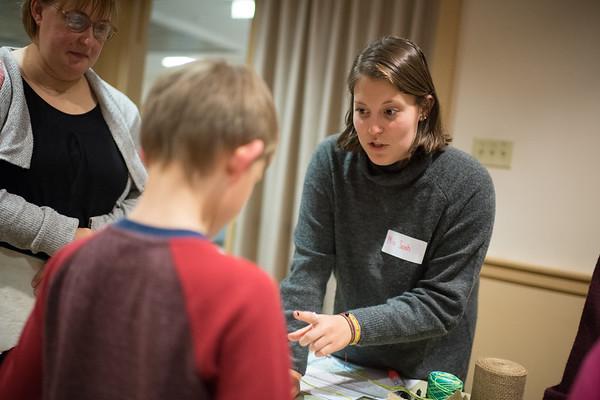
[174,239,291,400]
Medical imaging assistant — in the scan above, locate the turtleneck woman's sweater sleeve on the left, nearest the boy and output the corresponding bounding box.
[280,141,335,374]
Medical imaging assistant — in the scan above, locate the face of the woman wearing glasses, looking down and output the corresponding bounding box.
[32,1,104,80]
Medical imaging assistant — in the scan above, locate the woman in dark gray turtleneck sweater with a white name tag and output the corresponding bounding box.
[281,37,495,396]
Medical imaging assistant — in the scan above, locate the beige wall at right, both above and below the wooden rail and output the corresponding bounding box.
[448,0,600,400]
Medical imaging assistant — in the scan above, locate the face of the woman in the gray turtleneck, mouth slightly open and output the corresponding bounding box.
[353,76,421,165]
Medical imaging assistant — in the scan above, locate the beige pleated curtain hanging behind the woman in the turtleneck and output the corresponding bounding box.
[228,0,440,280]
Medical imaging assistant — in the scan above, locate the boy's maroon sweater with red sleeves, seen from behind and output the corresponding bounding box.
[0,220,291,400]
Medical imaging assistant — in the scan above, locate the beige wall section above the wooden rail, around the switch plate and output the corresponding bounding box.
[449,0,600,273]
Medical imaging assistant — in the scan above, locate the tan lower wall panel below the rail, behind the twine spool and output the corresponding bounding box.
[466,277,585,400]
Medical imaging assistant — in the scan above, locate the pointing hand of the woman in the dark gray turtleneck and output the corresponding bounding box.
[288,311,352,357]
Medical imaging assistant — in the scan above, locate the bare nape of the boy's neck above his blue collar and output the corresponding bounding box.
[129,166,223,236]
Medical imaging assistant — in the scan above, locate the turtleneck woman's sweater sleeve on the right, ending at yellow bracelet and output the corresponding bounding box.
[349,164,495,346]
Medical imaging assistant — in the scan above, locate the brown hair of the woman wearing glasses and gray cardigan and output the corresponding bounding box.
[21,0,117,40]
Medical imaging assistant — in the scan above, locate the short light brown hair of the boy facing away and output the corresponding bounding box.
[140,61,277,179]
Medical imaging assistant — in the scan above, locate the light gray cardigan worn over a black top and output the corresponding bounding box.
[0,47,146,255]
